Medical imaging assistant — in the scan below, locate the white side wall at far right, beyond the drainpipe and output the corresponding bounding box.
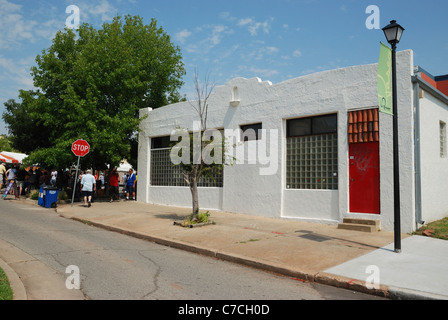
[420,91,448,223]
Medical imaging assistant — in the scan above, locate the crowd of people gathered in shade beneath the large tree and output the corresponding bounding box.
[0,159,137,207]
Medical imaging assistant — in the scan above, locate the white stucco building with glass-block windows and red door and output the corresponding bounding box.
[137,50,448,232]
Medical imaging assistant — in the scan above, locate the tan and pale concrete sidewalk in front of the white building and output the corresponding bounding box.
[50,200,448,300]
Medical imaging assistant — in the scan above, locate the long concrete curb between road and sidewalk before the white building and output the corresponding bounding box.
[65,213,410,300]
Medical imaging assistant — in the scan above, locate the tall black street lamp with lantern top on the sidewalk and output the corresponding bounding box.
[383,20,404,253]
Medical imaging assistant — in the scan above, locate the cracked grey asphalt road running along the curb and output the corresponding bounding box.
[0,200,381,300]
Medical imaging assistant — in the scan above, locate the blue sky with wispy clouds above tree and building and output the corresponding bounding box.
[0,0,448,134]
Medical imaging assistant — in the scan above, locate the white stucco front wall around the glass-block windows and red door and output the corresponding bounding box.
[137,50,415,232]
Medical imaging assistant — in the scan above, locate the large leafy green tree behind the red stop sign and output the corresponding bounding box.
[3,15,185,169]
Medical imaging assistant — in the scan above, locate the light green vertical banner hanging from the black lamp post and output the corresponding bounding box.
[378,43,393,115]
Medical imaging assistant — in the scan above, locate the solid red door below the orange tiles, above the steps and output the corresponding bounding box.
[349,142,380,214]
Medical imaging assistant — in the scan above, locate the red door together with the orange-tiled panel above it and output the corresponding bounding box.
[349,109,380,214]
